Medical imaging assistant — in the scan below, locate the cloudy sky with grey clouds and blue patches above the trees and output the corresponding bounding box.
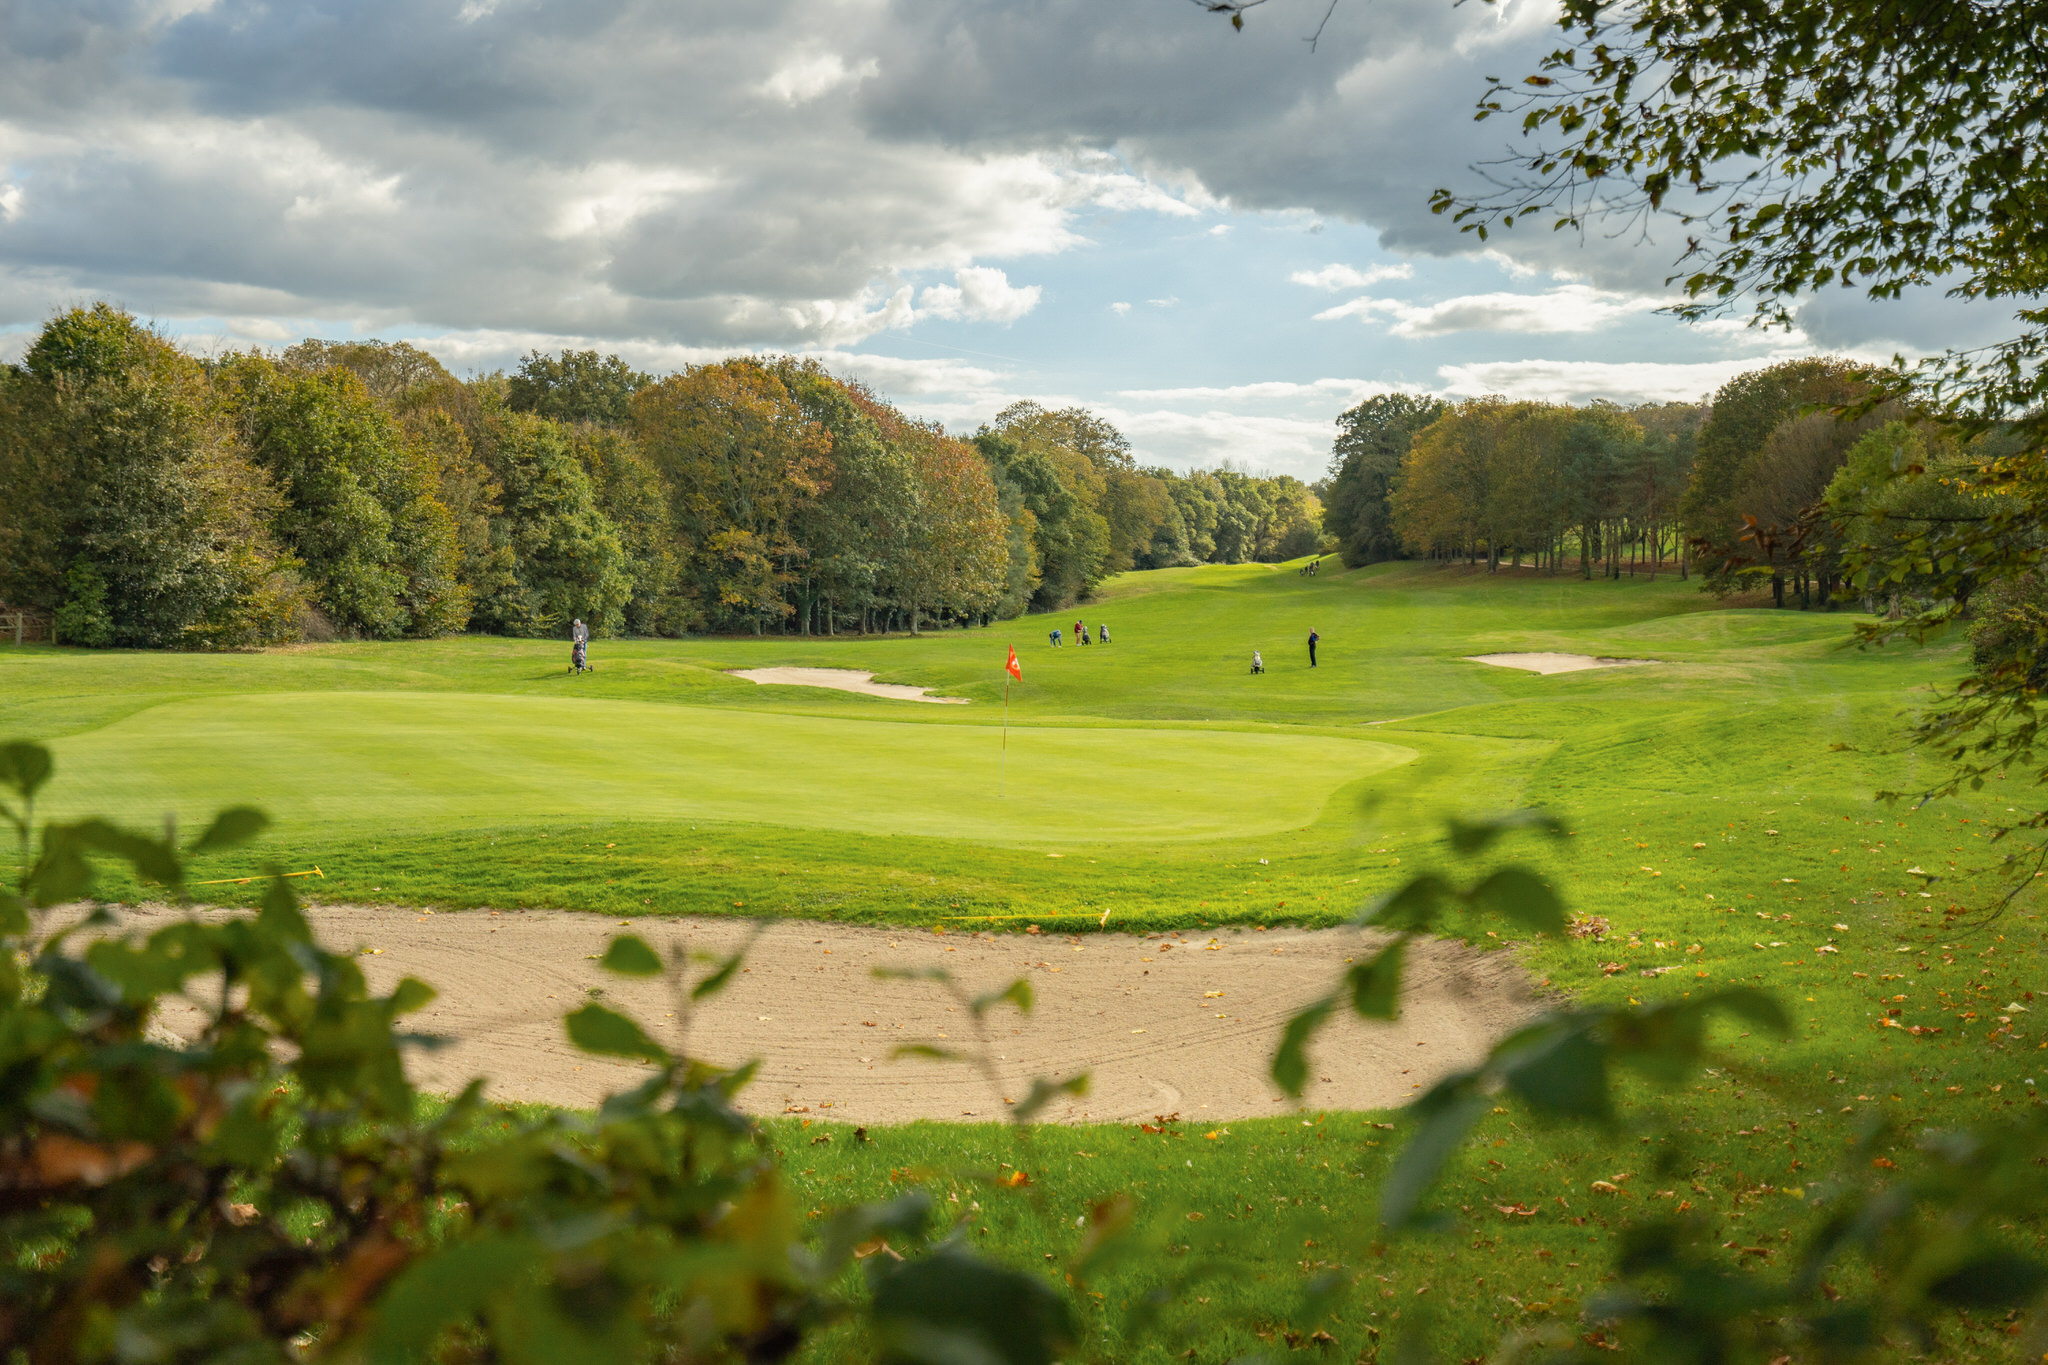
[0,0,2001,477]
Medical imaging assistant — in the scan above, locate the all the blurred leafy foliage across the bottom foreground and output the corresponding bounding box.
[0,745,2048,1365]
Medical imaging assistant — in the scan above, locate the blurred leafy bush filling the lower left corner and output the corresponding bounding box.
[0,745,1069,1365]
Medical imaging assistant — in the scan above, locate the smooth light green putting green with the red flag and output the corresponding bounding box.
[55,692,1415,843]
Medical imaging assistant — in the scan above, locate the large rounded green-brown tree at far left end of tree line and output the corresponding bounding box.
[0,303,305,649]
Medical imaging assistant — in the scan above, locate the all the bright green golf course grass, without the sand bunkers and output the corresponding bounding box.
[0,567,2048,1361]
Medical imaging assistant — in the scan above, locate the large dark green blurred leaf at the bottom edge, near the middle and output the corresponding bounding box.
[868,1242,1075,1365]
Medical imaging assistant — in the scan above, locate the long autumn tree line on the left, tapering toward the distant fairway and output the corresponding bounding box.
[0,303,1323,649]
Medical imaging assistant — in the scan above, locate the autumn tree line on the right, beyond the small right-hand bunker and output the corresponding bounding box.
[1319,356,2017,608]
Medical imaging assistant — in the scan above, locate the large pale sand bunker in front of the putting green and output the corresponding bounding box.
[129,907,1536,1124]
